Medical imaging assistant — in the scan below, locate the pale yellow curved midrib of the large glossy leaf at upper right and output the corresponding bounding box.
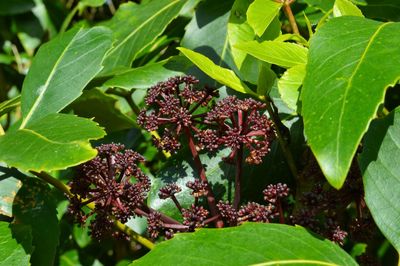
[336,22,392,175]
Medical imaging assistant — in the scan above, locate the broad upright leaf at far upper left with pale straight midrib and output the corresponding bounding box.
[21,27,111,128]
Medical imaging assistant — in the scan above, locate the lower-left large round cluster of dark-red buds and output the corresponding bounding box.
[68,144,150,239]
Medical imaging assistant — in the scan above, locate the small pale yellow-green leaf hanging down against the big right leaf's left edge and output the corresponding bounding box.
[278,65,306,111]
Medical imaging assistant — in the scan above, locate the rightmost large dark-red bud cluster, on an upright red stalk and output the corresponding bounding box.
[196,96,275,164]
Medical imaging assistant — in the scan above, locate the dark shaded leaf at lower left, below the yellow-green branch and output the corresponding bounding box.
[11,176,60,266]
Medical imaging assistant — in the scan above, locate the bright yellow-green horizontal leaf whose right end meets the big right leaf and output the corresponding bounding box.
[236,41,308,68]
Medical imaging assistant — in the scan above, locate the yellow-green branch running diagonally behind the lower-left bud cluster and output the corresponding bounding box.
[30,171,154,249]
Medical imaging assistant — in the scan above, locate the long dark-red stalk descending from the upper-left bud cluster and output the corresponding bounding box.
[184,127,224,228]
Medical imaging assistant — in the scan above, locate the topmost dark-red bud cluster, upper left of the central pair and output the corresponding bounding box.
[137,76,219,152]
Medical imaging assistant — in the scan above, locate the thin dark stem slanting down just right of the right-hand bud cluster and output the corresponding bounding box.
[266,97,298,180]
